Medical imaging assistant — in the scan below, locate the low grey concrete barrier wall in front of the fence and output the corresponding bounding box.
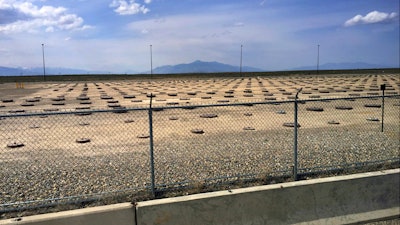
[0,169,400,225]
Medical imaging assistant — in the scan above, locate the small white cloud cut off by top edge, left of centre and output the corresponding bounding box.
[109,0,151,15]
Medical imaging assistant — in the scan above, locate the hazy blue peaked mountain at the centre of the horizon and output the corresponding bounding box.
[153,60,263,74]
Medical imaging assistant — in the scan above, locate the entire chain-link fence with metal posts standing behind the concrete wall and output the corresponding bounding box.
[0,92,400,213]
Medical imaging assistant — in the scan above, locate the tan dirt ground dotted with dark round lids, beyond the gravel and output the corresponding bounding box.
[0,74,400,156]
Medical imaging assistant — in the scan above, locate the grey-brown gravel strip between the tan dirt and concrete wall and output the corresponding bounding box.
[0,114,400,204]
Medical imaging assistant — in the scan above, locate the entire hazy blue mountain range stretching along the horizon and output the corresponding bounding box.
[0,60,398,76]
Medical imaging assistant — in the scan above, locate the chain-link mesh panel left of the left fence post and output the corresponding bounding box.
[0,110,150,211]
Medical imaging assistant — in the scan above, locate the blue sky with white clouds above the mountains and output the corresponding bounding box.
[0,0,400,73]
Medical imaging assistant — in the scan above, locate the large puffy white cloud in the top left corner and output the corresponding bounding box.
[0,0,90,33]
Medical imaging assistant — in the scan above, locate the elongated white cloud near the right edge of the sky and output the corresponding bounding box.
[344,11,398,27]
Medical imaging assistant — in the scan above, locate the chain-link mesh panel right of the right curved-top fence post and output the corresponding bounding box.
[298,98,400,175]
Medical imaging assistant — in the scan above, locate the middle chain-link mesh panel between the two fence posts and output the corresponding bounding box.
[150,103,293,188]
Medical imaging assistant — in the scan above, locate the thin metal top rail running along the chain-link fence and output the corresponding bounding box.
[0,94,400,118]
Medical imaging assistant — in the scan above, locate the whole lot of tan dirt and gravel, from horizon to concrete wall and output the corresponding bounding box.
[0,75,400,215]
